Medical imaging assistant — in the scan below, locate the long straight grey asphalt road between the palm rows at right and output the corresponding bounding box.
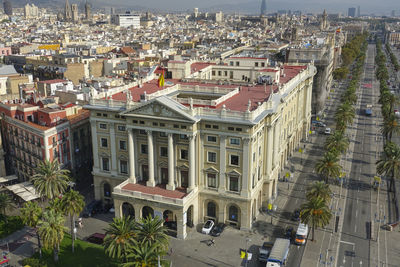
[337,44,379,267]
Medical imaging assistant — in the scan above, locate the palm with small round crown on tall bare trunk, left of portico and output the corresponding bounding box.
[61,189,85,252]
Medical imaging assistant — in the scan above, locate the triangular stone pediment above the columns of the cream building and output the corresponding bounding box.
[121,97,196,122]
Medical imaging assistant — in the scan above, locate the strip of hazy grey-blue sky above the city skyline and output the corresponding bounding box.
[96,0,400,14]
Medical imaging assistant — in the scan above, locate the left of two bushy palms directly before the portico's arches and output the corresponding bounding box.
[103,216,137,262]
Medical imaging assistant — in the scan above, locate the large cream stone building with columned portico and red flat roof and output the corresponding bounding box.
[86,64,316,238]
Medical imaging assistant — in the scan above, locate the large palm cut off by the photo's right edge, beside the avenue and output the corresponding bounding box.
[376,142,400,193]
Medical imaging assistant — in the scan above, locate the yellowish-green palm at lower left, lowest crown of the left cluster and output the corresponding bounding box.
[38,209,68,262]
